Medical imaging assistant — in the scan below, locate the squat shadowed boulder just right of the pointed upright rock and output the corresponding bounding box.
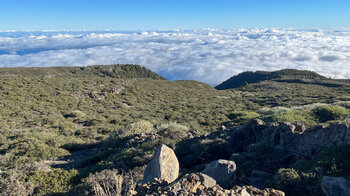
[202,159,236,189]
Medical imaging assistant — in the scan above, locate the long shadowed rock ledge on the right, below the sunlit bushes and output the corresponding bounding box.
[229,119,350,157]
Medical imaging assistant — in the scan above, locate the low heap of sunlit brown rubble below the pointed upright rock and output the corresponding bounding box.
[127,173,285,196]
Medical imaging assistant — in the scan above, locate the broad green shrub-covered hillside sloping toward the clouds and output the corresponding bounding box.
[0,65,350,195]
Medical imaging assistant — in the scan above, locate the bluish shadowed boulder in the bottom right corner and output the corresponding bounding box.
[321,176,350,196]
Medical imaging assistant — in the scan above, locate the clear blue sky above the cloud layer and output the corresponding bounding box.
[0,0,350,30]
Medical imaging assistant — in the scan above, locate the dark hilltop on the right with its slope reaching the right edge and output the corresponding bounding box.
[215,69,350,90]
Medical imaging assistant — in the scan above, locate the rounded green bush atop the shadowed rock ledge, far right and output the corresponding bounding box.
[313,105,349,123]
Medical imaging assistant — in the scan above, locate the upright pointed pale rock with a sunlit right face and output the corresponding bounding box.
[143,145,179,183]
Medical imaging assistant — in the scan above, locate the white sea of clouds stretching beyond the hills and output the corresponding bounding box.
[0,29,350,85]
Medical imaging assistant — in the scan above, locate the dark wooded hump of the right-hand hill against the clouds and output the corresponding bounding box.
[215,69,327,90]
